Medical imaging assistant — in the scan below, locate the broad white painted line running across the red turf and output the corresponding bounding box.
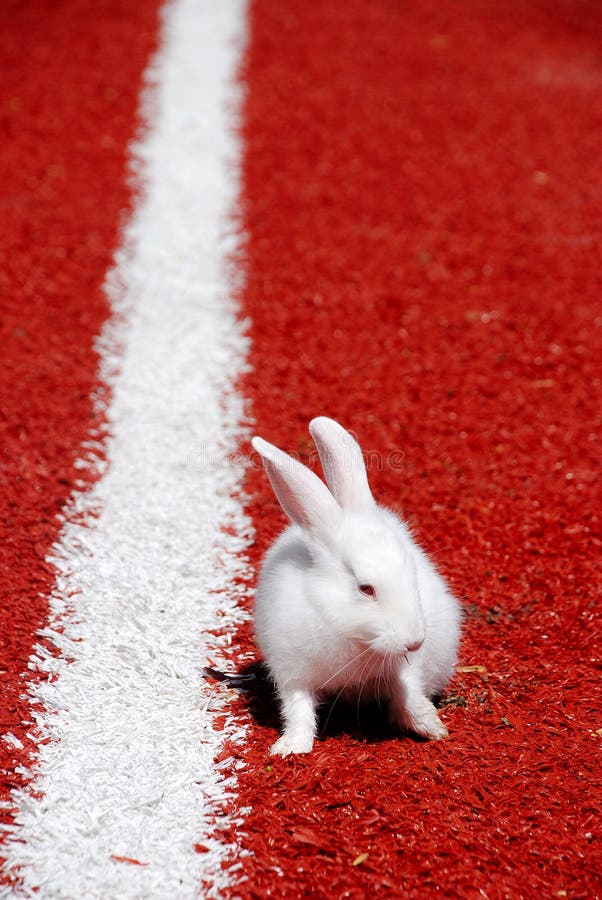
[2,0,249,900]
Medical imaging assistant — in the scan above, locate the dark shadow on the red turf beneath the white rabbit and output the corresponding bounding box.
[237,662,412,743]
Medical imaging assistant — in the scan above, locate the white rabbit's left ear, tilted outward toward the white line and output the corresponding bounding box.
[251,437,341,535]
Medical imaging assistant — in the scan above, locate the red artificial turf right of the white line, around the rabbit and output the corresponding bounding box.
[216,0,602,898]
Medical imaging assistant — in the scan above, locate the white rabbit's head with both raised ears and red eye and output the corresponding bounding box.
[253,416,426,657]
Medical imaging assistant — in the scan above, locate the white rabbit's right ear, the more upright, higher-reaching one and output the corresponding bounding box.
[309,416,375,511]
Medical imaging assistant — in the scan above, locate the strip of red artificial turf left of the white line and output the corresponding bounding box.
[0,0,158,852]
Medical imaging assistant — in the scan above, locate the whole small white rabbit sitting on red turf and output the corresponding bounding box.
[252,416,461,756]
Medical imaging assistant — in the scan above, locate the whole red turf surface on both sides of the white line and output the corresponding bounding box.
[0,0,602,898]
